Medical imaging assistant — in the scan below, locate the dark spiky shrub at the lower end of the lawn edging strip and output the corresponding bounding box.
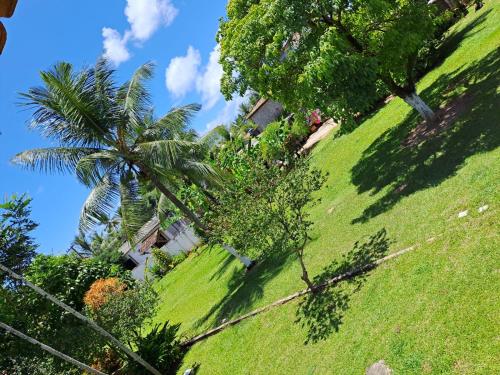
[128,321,184,375]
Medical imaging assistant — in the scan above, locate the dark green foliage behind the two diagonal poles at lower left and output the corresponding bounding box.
[0,255,132,373]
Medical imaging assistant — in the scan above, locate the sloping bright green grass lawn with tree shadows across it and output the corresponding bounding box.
[156,1,500,374]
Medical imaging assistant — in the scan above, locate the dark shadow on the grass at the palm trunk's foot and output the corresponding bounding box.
[194,243,292,328]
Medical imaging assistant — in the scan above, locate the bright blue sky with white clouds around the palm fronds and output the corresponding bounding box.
[0,0,241,254]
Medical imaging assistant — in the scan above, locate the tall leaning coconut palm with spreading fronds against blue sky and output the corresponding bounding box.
[13,60,217,239]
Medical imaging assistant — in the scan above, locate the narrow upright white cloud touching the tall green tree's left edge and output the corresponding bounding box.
[196,45,222,109]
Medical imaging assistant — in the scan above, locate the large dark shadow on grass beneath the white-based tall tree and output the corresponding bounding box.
[351,50,500,223]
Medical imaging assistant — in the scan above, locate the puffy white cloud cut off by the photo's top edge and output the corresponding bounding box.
[125,0,179,41]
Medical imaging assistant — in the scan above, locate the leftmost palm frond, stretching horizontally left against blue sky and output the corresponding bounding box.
[12,147,101,173]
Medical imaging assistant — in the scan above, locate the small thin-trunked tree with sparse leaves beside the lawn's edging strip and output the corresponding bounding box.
[209,154,326,290]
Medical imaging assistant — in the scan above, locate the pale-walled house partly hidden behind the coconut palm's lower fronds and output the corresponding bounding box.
[120,217,201,280]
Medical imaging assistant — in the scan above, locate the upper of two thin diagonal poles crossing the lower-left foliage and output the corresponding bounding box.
[0,263,162,375]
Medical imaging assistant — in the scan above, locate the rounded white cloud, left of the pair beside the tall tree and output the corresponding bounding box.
[165,46,201,98]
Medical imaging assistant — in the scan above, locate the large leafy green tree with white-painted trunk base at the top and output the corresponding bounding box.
[218,0,442,124]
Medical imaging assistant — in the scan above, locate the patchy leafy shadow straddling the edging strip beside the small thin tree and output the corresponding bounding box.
[295,229,390,344]
